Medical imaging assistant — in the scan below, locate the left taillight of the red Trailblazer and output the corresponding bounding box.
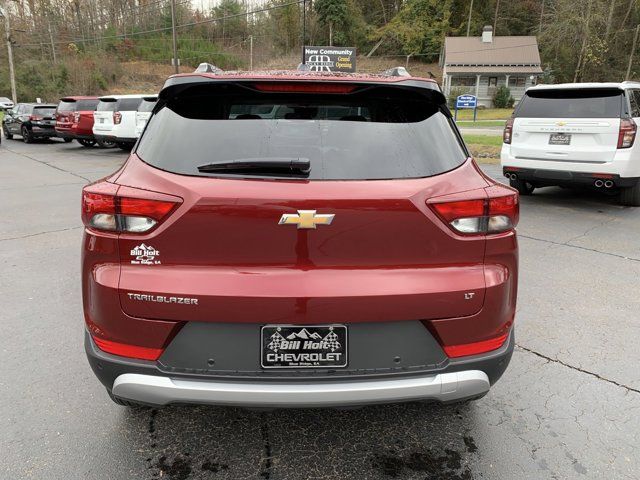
[82,182,182,233]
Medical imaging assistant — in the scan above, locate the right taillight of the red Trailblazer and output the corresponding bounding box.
[427,185,520,235]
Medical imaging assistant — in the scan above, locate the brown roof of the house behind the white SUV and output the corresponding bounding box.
[444,36,541,69]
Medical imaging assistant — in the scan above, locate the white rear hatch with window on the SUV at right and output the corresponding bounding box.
[510,89,623,163]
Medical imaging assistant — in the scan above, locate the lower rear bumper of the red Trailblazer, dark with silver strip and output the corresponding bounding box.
[85,331,515,408]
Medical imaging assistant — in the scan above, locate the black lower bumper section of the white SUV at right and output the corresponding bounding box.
[502,166,640,188]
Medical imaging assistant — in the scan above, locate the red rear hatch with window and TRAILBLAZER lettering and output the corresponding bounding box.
[117,80,487,324]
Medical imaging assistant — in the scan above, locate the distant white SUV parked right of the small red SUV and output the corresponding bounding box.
[93,95,147,150]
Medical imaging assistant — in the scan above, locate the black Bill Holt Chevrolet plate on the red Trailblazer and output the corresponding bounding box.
[260,325,347,368]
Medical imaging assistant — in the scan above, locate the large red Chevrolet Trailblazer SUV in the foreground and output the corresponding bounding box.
[82,72,518,407]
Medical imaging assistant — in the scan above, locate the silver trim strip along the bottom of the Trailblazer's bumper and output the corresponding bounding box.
[113,370,490,407]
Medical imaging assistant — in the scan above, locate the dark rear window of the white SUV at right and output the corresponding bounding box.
[515,89,623,118]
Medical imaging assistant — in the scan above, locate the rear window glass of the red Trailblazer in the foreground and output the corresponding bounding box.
[137,86,466,180]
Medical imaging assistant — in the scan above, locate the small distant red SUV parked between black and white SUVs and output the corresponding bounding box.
[56,96,99,147]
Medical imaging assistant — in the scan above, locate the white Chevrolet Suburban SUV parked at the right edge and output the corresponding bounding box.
[500,82,640,206]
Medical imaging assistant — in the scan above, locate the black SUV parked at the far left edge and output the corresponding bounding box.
[2,103,56,143]
